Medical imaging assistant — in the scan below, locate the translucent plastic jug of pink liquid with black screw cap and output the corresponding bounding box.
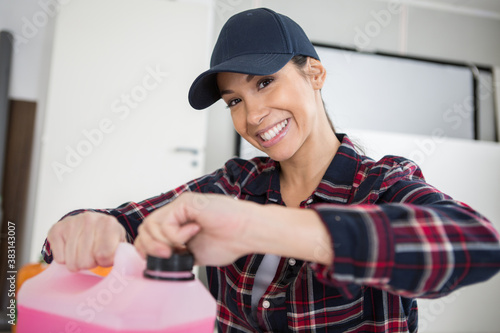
[17,243,216,333]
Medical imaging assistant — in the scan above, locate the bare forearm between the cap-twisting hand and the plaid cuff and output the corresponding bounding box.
[243,205,334,265]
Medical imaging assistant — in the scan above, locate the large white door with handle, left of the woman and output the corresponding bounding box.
[31,0,210,258]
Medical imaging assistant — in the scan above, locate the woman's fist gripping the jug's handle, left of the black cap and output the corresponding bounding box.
[47,212,126,271]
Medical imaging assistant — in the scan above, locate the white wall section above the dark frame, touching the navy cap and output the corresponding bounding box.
[262,0,403,51]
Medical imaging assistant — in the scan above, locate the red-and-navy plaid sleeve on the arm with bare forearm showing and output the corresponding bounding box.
[315,201,500,297]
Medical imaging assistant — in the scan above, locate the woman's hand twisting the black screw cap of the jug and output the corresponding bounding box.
[134,192,254,266]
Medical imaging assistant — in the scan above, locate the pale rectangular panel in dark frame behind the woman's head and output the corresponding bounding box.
[317,47,474,139]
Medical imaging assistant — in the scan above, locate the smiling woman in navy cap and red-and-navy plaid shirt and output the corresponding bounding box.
[44,8,500,332]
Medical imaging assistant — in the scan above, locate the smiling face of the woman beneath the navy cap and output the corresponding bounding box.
[217,58,331,161]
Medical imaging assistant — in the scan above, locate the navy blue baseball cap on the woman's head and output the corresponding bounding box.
[189,8,319,110]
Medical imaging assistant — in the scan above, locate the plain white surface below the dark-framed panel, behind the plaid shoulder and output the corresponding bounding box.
[350,131,500,333]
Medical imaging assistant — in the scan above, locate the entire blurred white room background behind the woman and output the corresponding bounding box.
[0,0,500,332]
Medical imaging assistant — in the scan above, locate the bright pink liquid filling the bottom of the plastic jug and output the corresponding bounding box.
[16,306,214,333]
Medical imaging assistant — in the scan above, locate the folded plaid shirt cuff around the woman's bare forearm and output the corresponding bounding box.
[311,204,394,298]
